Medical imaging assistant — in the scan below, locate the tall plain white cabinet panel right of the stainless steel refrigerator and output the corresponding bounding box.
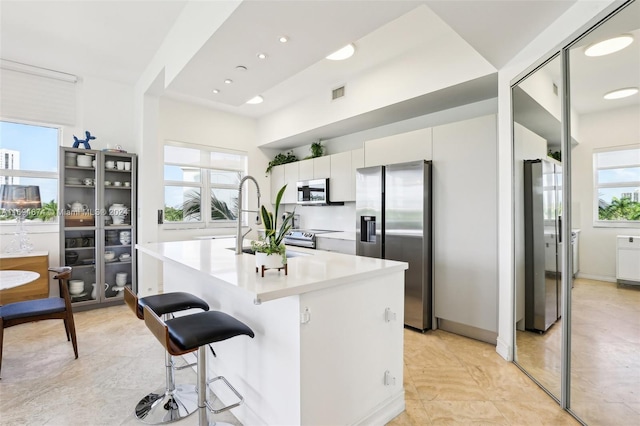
[433,115,498,342]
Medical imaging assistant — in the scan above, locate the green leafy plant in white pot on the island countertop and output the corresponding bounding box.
[251,185,293,268]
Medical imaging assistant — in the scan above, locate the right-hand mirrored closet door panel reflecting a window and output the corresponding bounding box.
[568,1,640,425]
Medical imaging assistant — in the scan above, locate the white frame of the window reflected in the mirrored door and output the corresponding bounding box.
[592,144,640,228]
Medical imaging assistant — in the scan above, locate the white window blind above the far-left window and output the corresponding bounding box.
[0,64,76,125]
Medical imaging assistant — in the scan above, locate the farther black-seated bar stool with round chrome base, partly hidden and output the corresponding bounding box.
[124,287,209,424]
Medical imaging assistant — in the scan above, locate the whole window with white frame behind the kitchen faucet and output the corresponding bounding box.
[164,142,247,227]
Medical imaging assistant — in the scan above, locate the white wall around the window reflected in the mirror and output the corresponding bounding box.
[571,106,640,281]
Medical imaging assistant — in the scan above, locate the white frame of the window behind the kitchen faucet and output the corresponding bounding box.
[162,140,249,230]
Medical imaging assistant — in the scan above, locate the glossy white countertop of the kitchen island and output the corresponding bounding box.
[136,240,408,303]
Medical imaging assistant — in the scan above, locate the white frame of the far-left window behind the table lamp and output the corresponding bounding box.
[0,117,64,230]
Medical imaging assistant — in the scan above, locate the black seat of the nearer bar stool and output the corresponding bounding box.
[165,311,254,351]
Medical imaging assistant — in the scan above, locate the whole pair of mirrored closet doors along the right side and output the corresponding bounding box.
[512,0,640,425]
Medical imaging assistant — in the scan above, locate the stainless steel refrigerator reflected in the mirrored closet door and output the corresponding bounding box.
[523,159,562,332]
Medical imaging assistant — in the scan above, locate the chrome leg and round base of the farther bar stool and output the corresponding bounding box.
[134,314,198,425]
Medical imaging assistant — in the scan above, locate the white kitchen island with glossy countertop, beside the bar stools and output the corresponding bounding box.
[136,239,408,426]
